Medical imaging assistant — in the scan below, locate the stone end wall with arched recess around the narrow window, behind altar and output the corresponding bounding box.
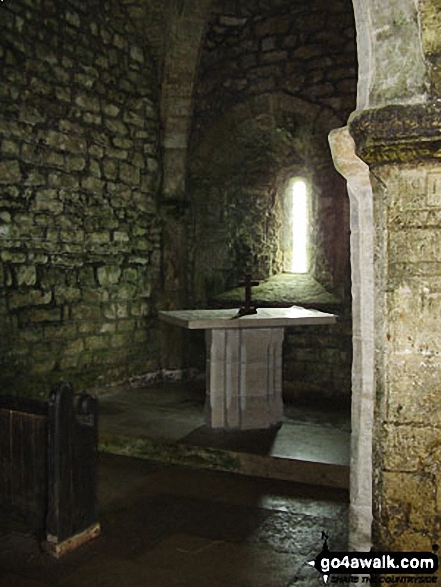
[184,13,354,406]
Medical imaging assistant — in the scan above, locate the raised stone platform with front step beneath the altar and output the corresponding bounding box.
[100,382,350,488]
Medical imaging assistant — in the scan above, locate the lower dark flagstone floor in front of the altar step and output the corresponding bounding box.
[0,454,347,587]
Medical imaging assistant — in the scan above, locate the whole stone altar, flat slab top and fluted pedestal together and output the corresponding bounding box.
[159,306,336,430]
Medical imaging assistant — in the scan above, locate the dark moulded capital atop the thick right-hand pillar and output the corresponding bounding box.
[349,102,441,166]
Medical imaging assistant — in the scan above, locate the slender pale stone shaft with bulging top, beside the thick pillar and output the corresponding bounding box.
[329,128,375,551]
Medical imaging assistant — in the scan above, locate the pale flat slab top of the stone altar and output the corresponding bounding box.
[159,306,337,330]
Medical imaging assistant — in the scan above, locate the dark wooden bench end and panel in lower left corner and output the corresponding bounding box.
[0,383,100,558]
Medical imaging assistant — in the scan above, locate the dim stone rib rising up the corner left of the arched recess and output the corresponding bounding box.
[161,0,211,370]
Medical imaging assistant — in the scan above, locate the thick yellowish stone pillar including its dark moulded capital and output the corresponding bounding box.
[349,104,441,551]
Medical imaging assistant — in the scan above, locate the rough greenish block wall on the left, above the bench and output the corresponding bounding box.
[0,0,161,395]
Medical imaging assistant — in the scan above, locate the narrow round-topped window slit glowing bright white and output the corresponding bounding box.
[291,180,308,273]
